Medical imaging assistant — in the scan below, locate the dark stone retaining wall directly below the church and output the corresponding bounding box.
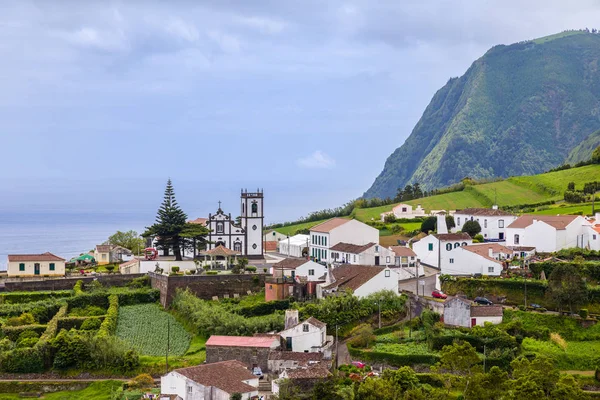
[148,272,265,307]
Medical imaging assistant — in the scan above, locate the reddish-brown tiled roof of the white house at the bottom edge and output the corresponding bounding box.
[174,360,258,395]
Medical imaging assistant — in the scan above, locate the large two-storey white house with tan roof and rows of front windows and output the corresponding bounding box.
[309,218,379,262]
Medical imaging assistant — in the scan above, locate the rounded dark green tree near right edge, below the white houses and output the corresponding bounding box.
[548,263,587,313]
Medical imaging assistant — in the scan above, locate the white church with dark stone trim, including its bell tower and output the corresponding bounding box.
[206,189,264,259]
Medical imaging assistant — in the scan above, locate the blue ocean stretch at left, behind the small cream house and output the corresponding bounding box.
[0,211,154,270]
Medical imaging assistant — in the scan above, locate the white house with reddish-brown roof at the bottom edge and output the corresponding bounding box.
[158,360,258,400]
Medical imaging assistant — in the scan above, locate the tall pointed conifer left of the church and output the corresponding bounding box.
[142,179,187,261]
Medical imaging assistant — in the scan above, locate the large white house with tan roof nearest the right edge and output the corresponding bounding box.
[506,215,591,252]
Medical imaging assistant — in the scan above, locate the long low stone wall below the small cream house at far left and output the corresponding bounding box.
[4,274,146,292]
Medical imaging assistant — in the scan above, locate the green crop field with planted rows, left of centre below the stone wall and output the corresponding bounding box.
[116,304,191,356]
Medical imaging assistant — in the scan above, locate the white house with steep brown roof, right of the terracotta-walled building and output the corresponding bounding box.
[317,265,399,298]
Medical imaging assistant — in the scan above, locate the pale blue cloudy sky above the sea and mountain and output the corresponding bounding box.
[0,0,600,222]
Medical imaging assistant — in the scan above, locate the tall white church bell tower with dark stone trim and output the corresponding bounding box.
[241,189,264,259]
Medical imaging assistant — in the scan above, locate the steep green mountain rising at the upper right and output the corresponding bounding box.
[364,31,600,198]
